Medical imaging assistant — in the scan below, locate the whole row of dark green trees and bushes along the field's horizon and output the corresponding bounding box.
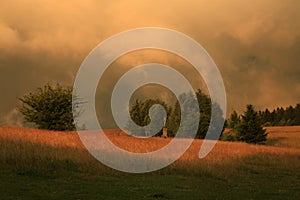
[19,83,284,143]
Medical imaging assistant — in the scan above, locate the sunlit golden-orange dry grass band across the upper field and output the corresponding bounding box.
[0,127,300,168]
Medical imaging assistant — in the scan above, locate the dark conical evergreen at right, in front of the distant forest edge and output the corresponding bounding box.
[236,105,267,144]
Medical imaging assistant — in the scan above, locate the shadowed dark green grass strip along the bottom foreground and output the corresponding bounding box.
[0,159,299,199]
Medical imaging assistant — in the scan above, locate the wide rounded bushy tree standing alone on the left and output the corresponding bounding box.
[18,83,79,131]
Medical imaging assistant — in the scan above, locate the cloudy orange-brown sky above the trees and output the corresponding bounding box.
[0,0,300,125]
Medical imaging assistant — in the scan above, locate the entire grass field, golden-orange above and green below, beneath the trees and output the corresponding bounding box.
[0,127,300,199]
